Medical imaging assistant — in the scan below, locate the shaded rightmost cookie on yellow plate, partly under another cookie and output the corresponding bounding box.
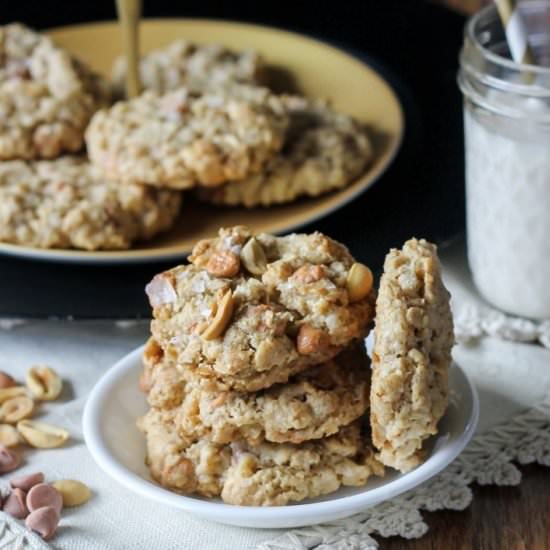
[197,97,372,208]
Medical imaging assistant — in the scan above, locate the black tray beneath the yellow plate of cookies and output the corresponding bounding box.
[0,0,464,318]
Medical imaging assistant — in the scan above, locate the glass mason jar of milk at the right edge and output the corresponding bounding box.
[458,0,550,319]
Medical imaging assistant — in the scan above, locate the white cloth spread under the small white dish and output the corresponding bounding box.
[0,244,550,550]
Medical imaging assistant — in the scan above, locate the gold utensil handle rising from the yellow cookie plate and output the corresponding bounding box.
[116,0,141,98]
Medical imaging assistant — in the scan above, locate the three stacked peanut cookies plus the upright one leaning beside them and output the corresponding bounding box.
[138,227,453,506]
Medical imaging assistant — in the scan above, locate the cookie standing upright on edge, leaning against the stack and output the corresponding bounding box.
[370,239,454,472]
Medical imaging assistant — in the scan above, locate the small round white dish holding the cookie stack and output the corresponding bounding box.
[83,348,479,528]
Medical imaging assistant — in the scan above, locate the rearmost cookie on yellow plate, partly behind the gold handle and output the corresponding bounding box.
[113,40,266,97]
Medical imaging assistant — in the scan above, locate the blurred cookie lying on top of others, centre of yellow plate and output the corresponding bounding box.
[86,85,288,189]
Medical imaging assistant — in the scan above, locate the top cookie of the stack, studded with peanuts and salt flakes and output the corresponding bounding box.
[146,226,374,391]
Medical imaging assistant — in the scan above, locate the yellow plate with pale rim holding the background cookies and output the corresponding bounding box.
[0,19,404,263]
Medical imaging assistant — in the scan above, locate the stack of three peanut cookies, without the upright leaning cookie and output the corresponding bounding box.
[139,227,383,505]
